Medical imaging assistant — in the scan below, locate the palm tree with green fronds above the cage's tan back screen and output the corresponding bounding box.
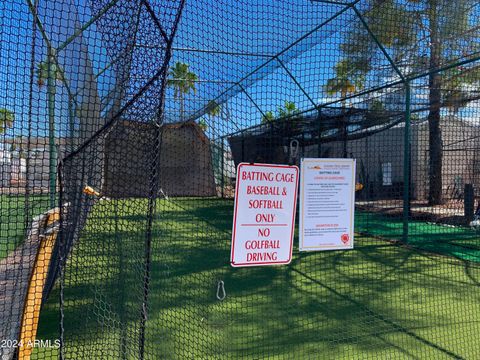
[167,61,198,121]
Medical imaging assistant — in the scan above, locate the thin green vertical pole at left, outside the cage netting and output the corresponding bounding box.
[47,48,57,209]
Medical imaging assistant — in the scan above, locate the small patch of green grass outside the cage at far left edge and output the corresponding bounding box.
[0,194,49,260]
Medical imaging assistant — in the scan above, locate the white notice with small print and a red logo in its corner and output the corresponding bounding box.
[299,159,355,251]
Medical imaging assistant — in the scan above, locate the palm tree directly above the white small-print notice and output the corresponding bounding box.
[324,60,365,158]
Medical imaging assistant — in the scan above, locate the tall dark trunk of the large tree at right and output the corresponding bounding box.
[428,0,443,205]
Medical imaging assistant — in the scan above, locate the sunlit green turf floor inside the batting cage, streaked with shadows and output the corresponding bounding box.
[31,199,480,359]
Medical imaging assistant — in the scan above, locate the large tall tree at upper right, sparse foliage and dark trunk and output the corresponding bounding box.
[336,0,480,205]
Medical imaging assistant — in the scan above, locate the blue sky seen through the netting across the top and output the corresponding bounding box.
[0,0,480,143]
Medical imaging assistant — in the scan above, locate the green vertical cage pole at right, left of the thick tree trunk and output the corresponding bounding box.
[403,81,411,243]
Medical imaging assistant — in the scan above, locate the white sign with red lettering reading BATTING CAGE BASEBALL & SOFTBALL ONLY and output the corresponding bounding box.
[230,163,298,267]
